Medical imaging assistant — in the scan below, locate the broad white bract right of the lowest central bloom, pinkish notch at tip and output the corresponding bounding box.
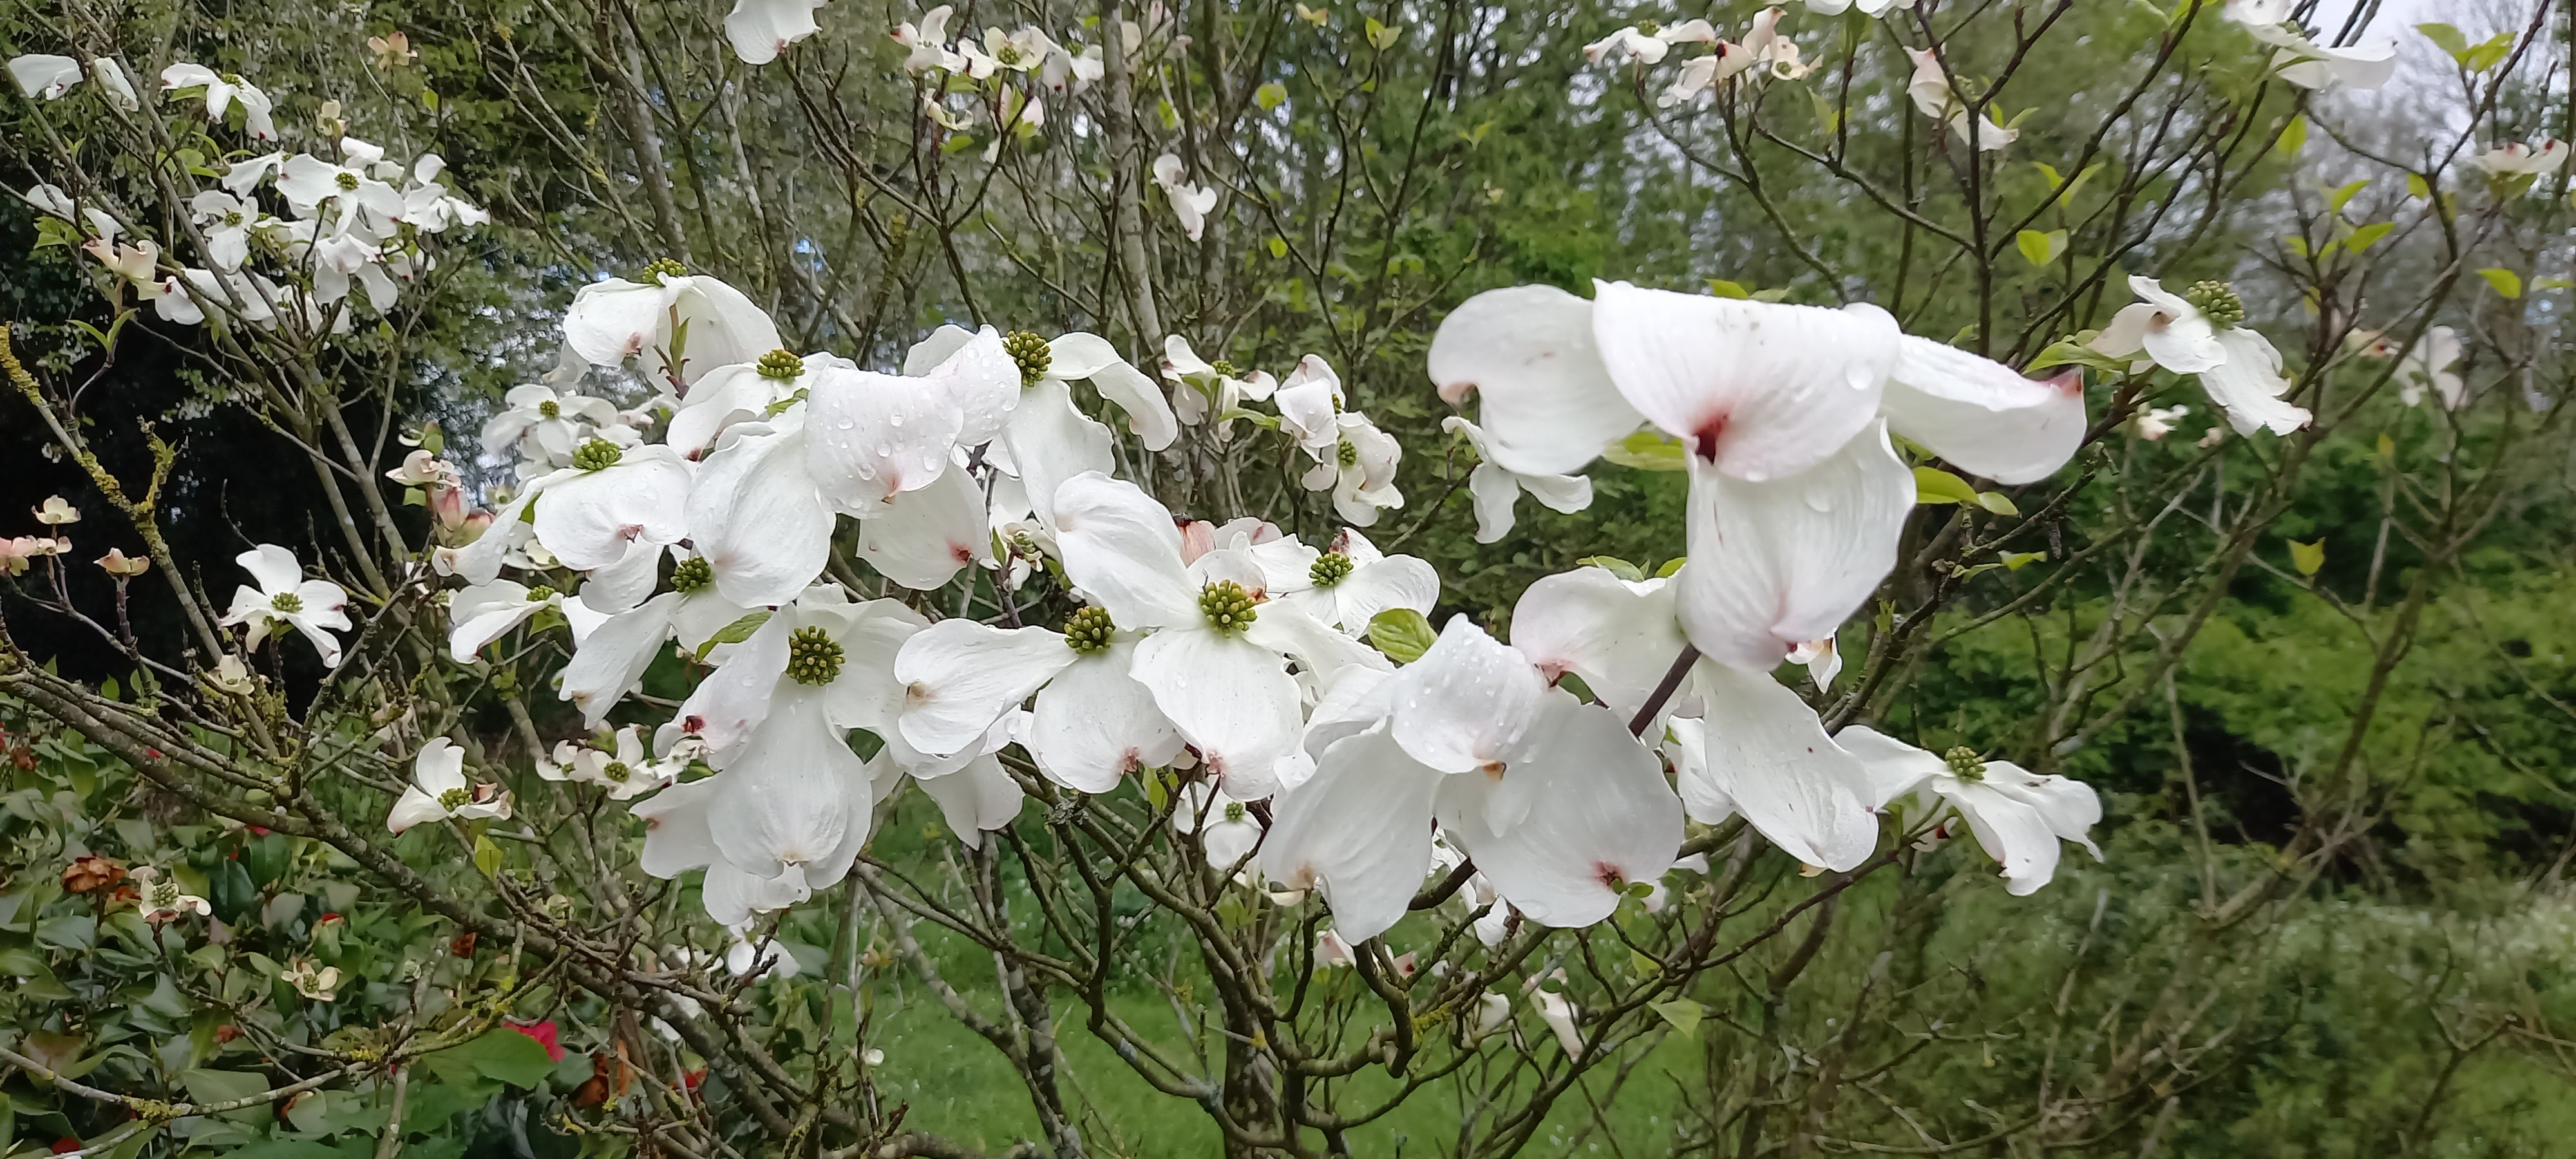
[1437,690,1682,927]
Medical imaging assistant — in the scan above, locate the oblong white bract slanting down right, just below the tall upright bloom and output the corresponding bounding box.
[1685,664,1878,871]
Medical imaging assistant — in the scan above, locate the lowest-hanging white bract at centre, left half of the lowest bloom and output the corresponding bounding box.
[1260,726,1448,943]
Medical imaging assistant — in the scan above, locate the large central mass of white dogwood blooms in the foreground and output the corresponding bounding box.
[376,263,2099,943]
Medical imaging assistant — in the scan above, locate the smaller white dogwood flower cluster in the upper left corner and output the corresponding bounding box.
[8,54,489,332]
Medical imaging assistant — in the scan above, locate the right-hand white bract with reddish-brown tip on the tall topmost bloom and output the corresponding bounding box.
[1880,335,2084,484]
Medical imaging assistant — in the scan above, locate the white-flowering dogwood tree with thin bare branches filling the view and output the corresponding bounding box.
[0,0,2566,1156]
